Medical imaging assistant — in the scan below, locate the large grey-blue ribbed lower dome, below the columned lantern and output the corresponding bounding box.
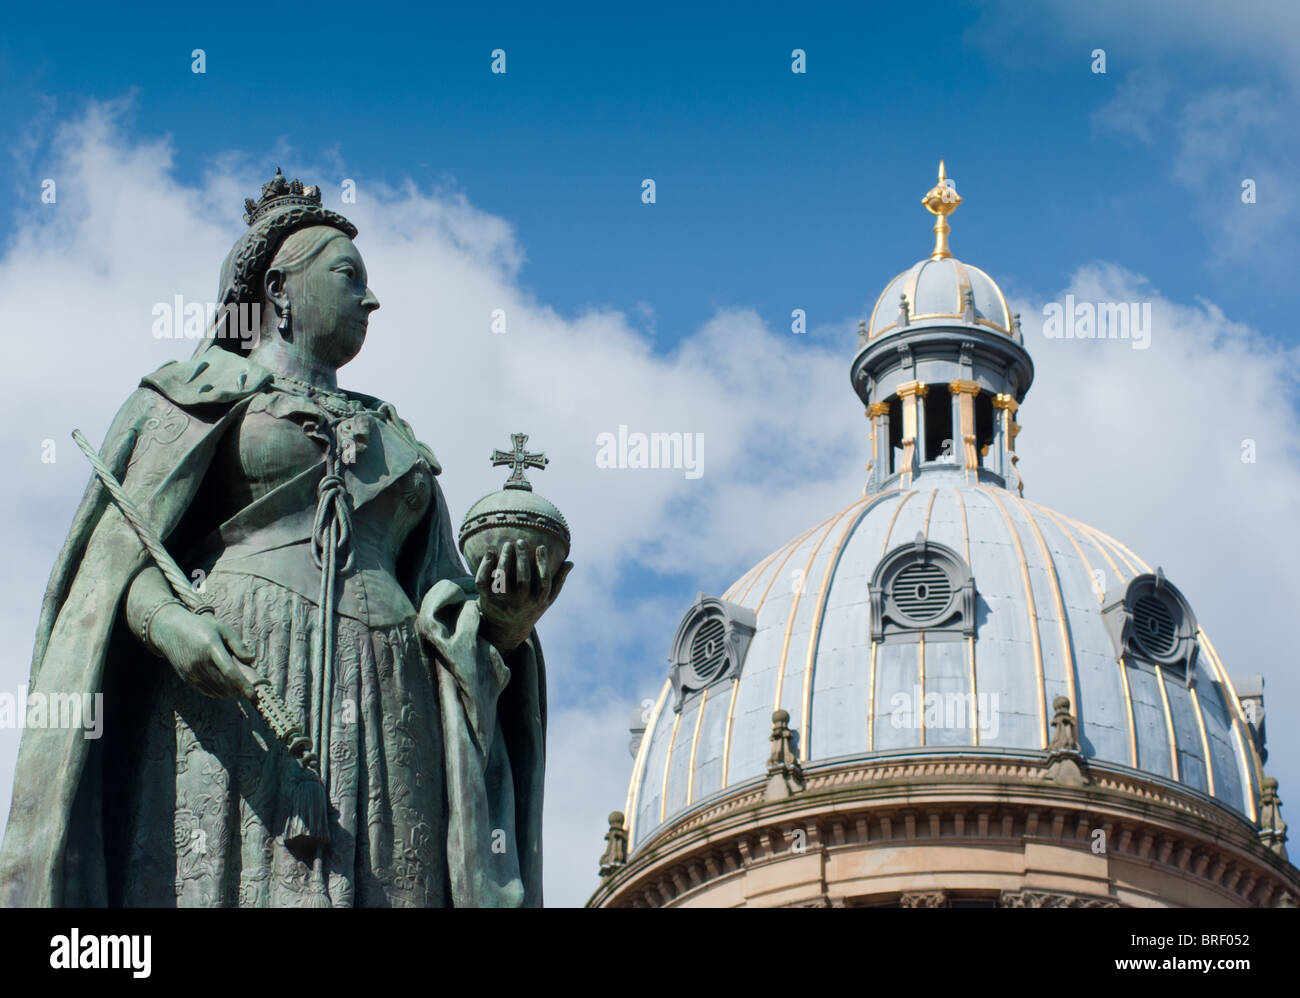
[627,470,1260,847]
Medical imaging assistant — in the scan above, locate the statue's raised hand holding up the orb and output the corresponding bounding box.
[475,541,573,655]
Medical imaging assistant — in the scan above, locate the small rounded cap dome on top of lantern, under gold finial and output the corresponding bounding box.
[867,256,1014,339]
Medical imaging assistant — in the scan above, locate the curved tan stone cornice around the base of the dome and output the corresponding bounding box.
[589,750,1300,906]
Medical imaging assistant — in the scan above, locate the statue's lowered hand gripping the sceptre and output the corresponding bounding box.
[150,603,259,699]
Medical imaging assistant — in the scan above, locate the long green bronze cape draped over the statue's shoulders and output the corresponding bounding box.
[0,348,546,907]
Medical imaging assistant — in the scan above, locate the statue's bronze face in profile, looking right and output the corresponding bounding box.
[285,233,380,368]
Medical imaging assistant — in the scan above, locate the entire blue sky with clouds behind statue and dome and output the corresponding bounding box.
[0,0,1300,903]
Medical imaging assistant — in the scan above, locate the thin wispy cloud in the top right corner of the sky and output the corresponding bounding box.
[967,0,1300,268]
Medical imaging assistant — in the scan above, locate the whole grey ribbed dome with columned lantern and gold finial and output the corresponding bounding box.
[625,164,1262,849]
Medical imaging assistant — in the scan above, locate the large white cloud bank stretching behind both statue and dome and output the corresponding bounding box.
[0,108,1300,904]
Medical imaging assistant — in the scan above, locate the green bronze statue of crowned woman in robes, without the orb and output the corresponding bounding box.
[0,170,572,907]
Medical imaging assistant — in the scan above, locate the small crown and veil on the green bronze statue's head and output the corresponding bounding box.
[195,168,366,353]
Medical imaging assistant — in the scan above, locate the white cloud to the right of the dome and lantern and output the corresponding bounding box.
[1017,264,1300,797]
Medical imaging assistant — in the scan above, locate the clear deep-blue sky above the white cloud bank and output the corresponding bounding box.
[0,3,1296,343]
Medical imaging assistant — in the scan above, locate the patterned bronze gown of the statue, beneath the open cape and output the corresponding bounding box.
[104,391,451,907]
